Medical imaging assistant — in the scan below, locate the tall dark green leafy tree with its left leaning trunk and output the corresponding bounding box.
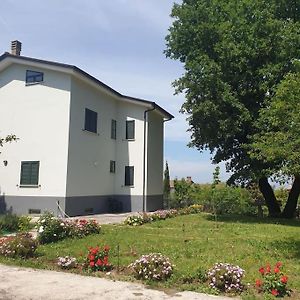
[166,0,300,216]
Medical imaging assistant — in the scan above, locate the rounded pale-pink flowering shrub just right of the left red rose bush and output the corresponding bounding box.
[129,253,174,280]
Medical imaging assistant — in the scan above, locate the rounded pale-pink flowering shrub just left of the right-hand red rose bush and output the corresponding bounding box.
[207,263,245,293]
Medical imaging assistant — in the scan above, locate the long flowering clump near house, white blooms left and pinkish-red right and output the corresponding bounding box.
[37,213,101,244]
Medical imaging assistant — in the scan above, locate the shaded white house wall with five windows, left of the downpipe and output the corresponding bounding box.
[67,78,146,197]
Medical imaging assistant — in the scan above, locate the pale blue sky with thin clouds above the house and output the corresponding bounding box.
[0,0,228,183]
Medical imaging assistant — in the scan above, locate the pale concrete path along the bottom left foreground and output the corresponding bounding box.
[0,264,233,300]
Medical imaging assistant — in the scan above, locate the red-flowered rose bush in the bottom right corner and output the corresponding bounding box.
[255,262,290,297]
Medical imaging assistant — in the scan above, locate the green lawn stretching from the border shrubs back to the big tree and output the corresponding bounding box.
[0,214,300,299]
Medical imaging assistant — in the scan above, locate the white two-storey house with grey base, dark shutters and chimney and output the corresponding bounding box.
[0,41,173,216]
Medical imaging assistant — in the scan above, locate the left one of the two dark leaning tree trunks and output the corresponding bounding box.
[258,177,281,217]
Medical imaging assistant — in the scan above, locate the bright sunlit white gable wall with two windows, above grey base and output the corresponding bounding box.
[0,64,70,196]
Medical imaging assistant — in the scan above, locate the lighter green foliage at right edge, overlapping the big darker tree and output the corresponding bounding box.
[250,72,300,181]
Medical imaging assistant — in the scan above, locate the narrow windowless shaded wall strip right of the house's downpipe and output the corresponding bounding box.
[147,111,164,195]
